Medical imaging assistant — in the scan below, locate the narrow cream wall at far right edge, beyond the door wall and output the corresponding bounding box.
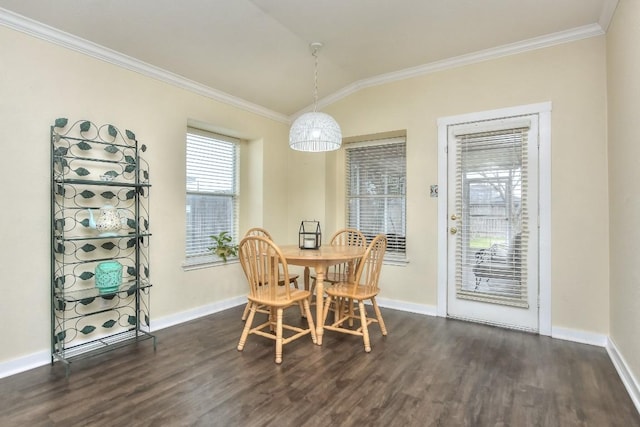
[607,0,640,386]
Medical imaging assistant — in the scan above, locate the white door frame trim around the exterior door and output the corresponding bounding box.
[437,102,551,336]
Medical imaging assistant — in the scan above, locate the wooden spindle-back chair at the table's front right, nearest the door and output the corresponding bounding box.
[323,234,387,353]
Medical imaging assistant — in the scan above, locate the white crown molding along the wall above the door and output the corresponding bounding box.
[290,23,604,120]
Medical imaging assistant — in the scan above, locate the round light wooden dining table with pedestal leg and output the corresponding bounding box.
[280,245,366,345]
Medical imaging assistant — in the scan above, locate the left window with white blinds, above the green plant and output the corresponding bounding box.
[185,128,239,265]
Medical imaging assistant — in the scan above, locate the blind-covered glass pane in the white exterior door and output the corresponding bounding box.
[456,122,530,307]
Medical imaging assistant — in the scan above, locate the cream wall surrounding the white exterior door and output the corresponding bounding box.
[326,37,609,335]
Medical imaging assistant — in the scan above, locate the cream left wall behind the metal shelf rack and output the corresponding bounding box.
[0,27,288,363]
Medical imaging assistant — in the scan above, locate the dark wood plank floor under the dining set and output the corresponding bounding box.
[0,307,640,427]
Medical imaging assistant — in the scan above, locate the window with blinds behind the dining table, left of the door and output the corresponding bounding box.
[346,137,407,260]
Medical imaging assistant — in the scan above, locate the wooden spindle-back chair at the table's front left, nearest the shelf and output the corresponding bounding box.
[238,236,317,363]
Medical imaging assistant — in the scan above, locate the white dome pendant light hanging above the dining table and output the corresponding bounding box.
[289,42,342,152]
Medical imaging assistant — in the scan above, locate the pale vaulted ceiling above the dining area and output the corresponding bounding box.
[0,0,617,118]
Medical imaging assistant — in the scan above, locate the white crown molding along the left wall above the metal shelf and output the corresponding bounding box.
[0,8,289,124]
